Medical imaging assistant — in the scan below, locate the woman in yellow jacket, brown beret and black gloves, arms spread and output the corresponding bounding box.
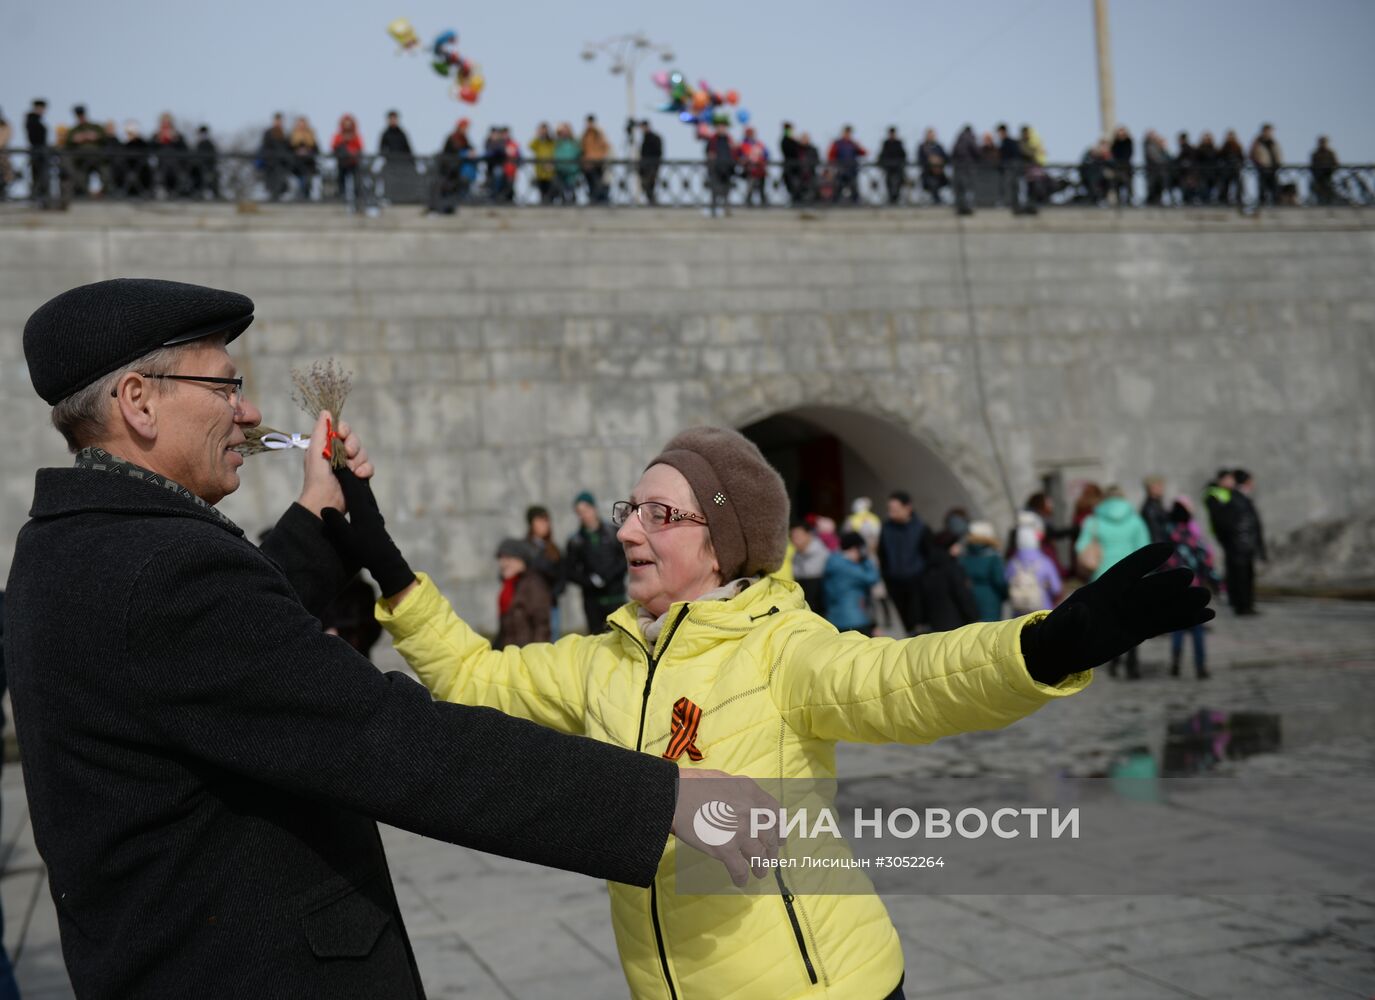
[335,428,1213,1000]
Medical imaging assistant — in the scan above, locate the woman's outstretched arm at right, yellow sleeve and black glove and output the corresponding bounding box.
[769,542,1214,743]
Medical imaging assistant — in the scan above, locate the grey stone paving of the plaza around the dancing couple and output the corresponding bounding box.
[0,598,1375,1000]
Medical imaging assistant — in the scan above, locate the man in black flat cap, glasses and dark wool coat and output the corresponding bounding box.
[4,279,767,1000]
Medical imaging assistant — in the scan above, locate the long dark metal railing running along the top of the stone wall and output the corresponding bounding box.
[0,147,1375,213]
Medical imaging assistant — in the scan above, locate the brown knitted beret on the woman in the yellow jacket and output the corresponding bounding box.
[645,426,788,580]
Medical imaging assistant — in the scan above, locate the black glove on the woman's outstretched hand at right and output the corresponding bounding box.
[1022,542,1216,685]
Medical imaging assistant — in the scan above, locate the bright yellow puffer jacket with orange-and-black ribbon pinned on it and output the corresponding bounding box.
[377,575,1090,1000]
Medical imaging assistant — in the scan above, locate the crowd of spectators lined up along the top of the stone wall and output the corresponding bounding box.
[0,99,1343,212]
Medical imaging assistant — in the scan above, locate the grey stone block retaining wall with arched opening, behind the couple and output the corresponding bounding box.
[0,205,1375,626]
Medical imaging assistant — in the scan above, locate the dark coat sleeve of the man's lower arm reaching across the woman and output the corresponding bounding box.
[126,532,677,886]
